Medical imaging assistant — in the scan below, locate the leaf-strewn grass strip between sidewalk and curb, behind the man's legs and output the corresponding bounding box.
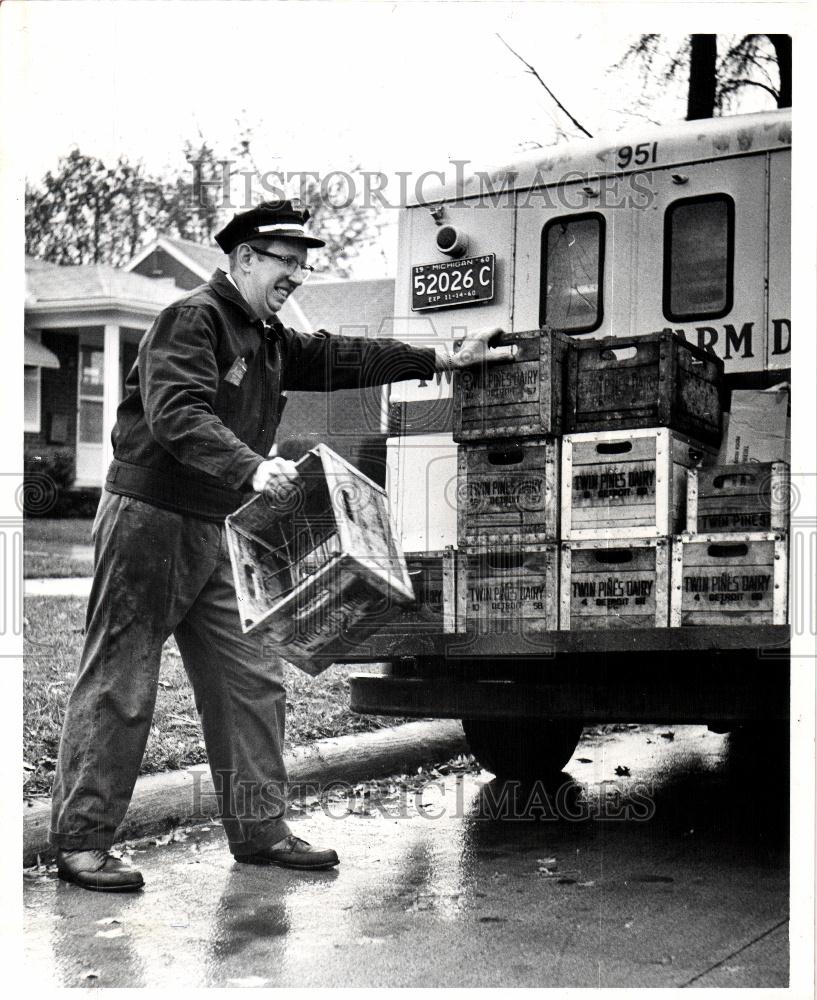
[23,597,404,797]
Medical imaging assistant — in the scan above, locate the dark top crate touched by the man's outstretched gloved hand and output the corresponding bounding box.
[454,329,573,441]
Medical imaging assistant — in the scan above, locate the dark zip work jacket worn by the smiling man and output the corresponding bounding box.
[111,271,435,521]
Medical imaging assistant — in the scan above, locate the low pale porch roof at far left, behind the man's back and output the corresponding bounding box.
[26,257,179,312]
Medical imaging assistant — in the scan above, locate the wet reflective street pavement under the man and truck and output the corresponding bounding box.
[25,726,788,987]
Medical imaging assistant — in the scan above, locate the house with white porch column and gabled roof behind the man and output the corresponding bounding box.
[24,237,394,488]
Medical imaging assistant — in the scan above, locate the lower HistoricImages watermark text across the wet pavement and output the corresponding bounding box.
[190,769,656,823]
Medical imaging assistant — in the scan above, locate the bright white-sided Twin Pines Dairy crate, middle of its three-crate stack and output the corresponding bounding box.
[562,427,716,541]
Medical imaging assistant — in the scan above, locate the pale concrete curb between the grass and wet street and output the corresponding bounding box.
[23,719,468,866]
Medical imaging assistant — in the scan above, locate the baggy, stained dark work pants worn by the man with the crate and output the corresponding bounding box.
[51,490,289,853]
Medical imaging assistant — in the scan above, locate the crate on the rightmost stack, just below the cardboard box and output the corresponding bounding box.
[686,462,790,535]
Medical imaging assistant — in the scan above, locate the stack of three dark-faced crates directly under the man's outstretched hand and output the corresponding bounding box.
[454,330,572,637]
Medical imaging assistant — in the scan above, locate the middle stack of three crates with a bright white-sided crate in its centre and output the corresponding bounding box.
[560,332,723,629]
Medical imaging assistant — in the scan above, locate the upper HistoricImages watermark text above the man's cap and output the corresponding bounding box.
[190,160,656,212]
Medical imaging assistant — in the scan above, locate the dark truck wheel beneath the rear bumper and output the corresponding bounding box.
[462,719,584,781]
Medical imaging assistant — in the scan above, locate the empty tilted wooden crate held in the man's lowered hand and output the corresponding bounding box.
[226,445,414,674]
